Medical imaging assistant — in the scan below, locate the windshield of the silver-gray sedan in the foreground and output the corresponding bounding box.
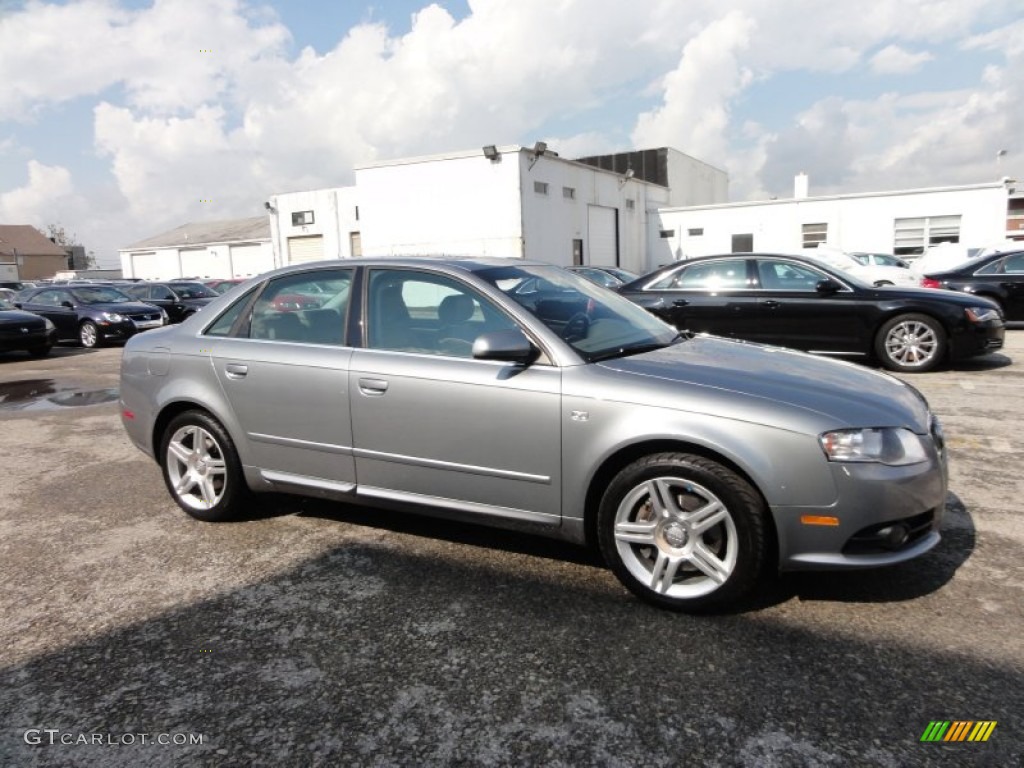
[476,265,679,362]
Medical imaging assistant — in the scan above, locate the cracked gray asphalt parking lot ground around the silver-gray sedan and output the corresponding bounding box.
[0,339,1024,766]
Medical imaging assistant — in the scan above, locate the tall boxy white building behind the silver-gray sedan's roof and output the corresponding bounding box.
[268,143,728,271]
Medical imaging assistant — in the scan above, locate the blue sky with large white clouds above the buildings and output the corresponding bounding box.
[0,0,1024,266]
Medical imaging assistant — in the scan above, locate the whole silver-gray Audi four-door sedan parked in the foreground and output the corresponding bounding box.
[120,258,947,609]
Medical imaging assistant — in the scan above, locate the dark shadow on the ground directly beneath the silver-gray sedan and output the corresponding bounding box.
[246,493,976,614]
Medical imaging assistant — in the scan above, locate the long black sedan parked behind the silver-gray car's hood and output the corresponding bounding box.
[618,254,1006,372]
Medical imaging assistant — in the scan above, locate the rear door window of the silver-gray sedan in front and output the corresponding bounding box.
[246,269,352,346]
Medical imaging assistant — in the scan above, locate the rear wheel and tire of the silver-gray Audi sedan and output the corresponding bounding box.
[159,411,251,522]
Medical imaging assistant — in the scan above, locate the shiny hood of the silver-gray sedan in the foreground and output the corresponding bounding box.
[597,336,929,433]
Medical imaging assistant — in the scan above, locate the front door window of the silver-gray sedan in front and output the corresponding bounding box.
[367,269,516,357]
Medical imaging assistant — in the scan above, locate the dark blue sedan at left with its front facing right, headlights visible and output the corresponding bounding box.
[17,286,167,347]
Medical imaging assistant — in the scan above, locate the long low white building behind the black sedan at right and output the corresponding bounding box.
[657,174,1024,259]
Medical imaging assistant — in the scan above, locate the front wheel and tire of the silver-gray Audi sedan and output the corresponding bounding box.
[597,454,769,611]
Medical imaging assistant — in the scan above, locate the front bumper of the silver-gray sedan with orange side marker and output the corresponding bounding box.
[772,451,948,570]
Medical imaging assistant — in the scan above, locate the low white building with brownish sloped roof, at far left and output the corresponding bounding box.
[120,216,274,280]
